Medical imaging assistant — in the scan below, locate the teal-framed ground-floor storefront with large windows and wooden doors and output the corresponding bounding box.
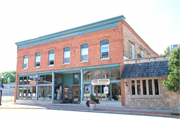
[17,64,121,104]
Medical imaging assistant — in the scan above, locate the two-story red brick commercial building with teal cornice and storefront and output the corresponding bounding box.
[15,16,165,107]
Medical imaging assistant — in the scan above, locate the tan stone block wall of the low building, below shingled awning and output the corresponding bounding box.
[125,78,180,110]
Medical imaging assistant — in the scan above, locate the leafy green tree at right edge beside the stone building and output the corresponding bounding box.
[163,45,180,92]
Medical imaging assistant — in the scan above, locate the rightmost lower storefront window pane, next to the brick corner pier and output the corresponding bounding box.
[111,83,121,100]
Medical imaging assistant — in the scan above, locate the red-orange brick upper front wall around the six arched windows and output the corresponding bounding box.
[17,22,123,73]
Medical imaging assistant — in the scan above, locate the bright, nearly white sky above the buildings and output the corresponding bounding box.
[0,0,180,72]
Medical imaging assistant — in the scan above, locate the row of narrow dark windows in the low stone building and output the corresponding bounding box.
[131,79,159,96]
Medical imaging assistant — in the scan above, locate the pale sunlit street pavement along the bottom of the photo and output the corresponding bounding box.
[0,109,177,120]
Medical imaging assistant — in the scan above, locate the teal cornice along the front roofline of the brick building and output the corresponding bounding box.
[15,15,125,46]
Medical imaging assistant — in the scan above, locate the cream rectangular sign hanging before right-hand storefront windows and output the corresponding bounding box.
[91,79,110,85]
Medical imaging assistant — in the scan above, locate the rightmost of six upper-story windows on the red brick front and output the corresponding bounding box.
[101,40,109,59]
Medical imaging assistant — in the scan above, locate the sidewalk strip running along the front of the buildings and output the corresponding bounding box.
[0,103,180,118]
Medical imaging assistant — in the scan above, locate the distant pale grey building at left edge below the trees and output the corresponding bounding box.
[2,83,15,96]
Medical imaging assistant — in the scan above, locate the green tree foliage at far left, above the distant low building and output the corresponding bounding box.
[0,70,16,84]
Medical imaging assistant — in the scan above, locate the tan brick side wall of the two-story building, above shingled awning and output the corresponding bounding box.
[122,21,157,59]
